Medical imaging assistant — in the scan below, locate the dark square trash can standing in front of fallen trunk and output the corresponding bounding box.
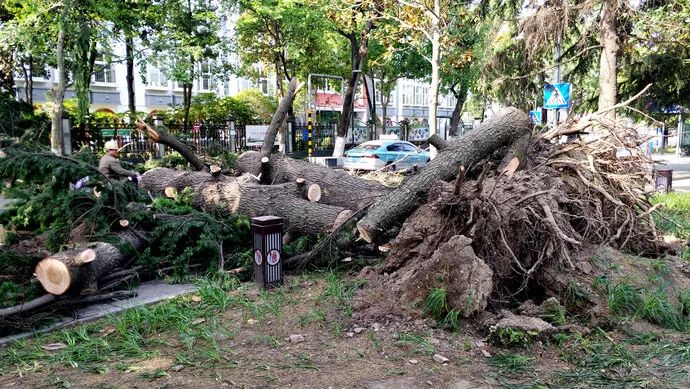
[252,216,283,289]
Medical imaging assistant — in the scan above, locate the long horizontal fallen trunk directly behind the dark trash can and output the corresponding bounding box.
[139,168,351,234]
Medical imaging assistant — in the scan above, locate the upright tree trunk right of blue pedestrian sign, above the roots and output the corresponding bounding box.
[598,0,620,119]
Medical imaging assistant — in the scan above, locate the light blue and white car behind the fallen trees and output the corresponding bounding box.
[343,140,431,170]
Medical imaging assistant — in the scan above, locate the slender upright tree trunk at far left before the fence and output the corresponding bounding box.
[50,7,69,155]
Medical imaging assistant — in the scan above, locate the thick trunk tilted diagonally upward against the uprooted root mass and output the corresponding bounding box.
[357,108,532,243]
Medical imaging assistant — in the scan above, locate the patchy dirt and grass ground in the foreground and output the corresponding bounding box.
[0,273,690,388]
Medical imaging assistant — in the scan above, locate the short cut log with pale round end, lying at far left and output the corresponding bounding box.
[35,231,144,295]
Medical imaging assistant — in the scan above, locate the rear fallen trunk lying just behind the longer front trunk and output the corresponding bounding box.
[235,151,390,210]
